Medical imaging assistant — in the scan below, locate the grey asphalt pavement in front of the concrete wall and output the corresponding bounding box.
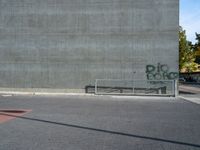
[0,95,200,150]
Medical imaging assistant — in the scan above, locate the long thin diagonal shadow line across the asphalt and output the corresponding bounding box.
[0,113,200,148]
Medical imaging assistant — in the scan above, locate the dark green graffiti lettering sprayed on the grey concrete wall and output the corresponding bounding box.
[146,63,178,80]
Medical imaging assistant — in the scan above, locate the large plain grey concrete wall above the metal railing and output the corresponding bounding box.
[0,0,179,89]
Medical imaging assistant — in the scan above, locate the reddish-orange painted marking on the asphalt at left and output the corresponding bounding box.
[0,109,32,123]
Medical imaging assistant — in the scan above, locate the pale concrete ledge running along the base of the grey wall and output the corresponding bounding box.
[0,88,176,100]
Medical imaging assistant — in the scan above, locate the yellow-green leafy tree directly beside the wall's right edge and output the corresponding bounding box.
[179,27,198,72]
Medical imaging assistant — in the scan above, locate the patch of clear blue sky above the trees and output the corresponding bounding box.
[180,0,200,43]
